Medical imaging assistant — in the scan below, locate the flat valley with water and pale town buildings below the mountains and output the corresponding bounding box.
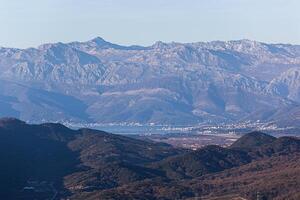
[64,121,299,150]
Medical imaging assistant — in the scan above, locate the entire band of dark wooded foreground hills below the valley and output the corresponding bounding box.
[0,118,300,200]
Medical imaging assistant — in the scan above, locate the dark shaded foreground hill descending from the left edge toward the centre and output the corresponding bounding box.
[0,119,180,199]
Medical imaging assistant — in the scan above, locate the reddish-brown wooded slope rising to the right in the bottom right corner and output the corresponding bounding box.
[88,154,300,200]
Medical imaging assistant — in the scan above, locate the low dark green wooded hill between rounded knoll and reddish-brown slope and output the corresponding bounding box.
[151,145,252,179]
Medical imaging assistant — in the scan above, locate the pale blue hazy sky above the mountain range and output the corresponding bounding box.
[0,0,300,48]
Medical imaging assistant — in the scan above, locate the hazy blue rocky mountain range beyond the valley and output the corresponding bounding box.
[0,38,300,126]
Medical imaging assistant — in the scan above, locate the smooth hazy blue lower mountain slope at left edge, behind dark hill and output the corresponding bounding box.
[0,81,89,121]
